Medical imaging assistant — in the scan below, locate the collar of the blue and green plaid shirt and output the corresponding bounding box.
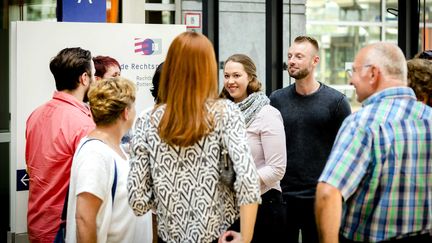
[362,87,417,107]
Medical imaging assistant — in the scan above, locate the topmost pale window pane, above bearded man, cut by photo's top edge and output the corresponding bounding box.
[306,0,381,22]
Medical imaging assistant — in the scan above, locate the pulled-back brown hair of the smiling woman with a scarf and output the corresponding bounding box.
[220,54,261,100]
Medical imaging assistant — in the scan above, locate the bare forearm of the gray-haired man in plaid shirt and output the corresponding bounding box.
[315,182,342,243]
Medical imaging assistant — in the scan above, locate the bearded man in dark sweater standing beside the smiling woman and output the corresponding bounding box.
[270,36,351,243]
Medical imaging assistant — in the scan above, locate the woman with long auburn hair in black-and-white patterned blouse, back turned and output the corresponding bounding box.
[128,32,260,243]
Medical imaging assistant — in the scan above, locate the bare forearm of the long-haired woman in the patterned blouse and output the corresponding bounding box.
[240,203,258,243]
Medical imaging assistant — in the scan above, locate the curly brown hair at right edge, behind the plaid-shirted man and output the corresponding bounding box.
[407,58,432,106]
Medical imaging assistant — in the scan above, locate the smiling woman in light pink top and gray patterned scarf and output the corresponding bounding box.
[221,54,286,242]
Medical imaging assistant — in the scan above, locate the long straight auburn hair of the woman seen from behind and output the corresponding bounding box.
[158,32,218,147]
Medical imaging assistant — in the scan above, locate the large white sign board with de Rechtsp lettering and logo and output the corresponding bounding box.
[10,22,186,233]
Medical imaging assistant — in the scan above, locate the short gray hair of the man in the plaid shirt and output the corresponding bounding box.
[367,42,408,83]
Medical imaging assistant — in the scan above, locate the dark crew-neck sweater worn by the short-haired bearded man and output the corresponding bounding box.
[270,83,351,198]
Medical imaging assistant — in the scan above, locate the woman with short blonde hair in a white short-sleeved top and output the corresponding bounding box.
[66,77,148,243]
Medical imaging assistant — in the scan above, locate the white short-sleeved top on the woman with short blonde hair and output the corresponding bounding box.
[66,137,152,243]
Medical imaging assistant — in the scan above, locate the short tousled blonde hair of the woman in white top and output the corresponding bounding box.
[88,77,136,125]
